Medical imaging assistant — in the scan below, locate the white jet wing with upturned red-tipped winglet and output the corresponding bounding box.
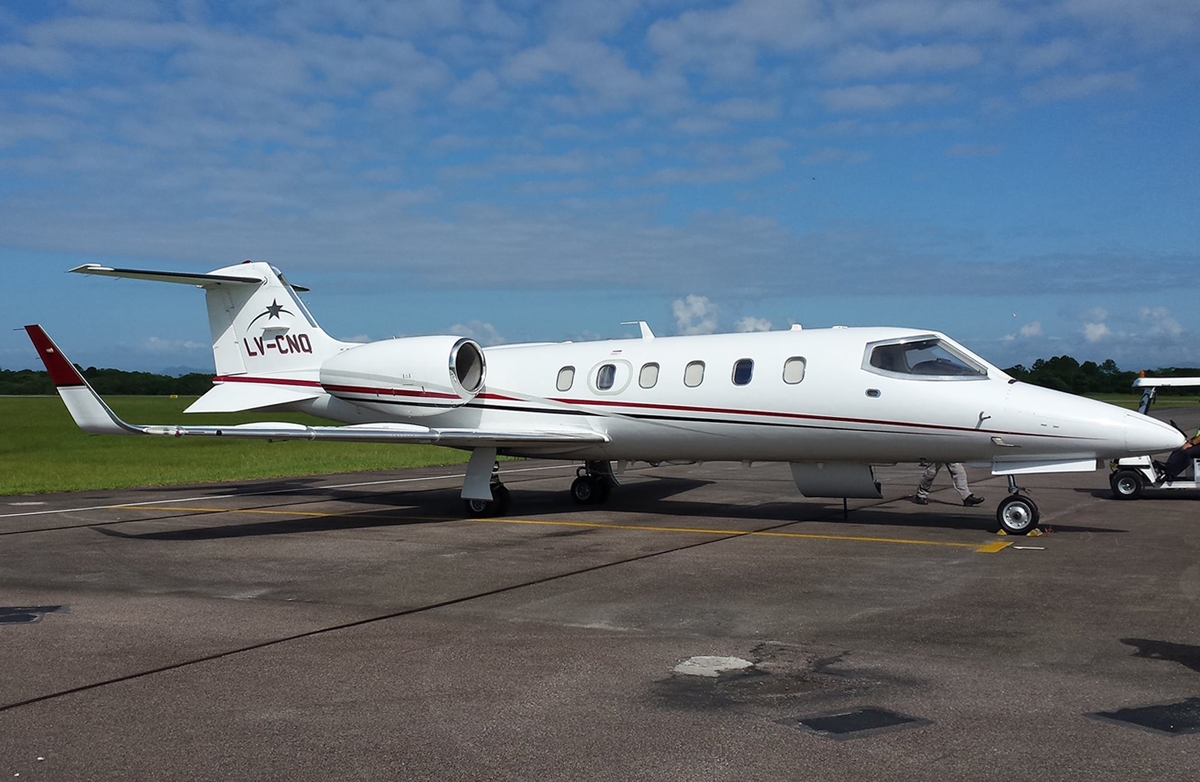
[25,325,610,449]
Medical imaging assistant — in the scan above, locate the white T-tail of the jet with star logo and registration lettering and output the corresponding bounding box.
[71,260,354,413]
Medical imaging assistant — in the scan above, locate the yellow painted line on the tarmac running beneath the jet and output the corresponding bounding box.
[138,505,1013,554]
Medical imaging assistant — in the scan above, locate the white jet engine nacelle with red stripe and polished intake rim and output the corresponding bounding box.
[320,336,487,417]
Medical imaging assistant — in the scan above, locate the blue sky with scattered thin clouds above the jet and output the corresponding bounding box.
[0,0,1200,371]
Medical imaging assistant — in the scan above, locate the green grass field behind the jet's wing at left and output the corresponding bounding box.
[0,396,468,495]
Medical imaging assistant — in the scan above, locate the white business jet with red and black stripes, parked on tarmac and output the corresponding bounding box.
[26,261,1183,534]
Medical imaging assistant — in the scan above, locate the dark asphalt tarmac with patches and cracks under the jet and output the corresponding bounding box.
[0,424,1200,781]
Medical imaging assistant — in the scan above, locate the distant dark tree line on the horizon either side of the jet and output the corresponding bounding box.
[0,356,1200,396]
